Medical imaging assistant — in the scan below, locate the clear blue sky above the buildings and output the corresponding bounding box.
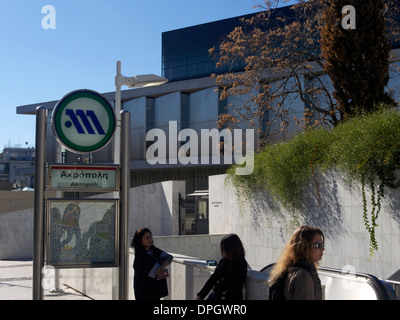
[0,0,296,152]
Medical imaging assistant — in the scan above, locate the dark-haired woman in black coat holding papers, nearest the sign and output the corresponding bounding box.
[132,228,173,300]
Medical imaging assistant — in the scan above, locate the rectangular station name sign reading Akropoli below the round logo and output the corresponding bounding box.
[48,164,119,192]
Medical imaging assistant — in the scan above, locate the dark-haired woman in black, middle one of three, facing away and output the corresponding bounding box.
[197,234,247,301]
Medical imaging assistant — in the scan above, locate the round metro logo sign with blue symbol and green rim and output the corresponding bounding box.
[53,90,116,153]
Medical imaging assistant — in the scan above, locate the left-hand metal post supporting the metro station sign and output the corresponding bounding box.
[32,107,47,300]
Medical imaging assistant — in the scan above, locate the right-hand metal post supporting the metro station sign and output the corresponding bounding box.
[118,110,131,300]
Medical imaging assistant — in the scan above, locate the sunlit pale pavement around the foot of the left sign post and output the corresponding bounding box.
[0,260,92,300]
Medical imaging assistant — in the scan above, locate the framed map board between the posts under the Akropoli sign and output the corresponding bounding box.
[47,199,119,268]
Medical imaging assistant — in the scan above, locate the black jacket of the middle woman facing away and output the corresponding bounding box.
[197,258,247,300]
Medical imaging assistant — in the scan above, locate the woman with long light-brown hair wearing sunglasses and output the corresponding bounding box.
[269,226,325,300]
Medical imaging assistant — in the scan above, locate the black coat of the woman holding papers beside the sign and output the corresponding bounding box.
[133,246,172,300]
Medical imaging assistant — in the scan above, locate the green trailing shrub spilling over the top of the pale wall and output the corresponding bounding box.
[228,106,400,257]
